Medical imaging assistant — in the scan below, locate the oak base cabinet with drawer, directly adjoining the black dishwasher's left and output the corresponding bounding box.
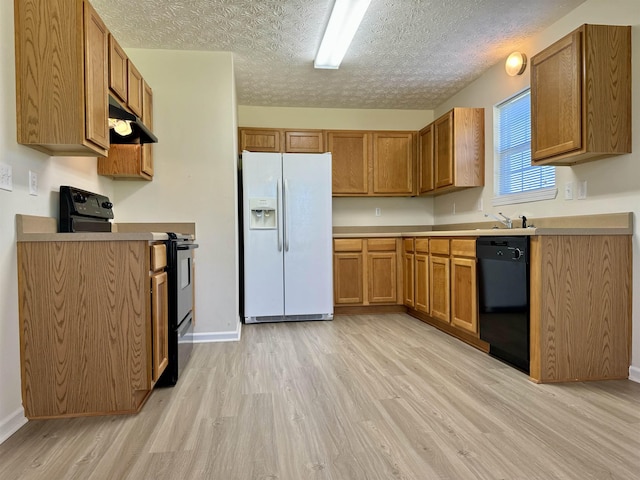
[451,238,479,336]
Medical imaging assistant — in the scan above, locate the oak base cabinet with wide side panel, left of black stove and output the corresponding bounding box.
[17,240,168,419]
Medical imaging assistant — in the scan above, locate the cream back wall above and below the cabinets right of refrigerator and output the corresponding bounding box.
[238,105,434,227]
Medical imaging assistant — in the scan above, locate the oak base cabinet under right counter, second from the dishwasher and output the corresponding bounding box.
[429,238,451,323]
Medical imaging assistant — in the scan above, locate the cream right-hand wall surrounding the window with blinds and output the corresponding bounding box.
[435,0,640,381]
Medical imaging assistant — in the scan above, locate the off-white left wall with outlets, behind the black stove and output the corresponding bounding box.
[0,2,113,442]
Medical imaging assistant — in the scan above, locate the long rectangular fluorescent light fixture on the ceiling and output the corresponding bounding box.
[313,0,371,69]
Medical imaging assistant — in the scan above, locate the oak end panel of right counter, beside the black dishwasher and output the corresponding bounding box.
[530,235,632,382]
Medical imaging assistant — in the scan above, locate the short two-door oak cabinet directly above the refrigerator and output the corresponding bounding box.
[238,127,325,153]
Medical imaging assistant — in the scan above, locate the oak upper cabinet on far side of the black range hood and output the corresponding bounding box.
[98,80,153,181]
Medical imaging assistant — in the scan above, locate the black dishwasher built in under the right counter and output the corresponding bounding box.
[476,237,529,373]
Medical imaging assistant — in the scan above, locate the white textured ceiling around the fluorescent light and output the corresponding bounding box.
[91,0,584,109]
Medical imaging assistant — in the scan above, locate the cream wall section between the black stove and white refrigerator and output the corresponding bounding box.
[113,49,240,340]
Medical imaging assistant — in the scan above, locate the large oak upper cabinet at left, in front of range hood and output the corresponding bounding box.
[15,0,109,156]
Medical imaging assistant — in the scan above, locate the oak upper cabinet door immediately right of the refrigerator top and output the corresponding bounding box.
[326,131,370,195]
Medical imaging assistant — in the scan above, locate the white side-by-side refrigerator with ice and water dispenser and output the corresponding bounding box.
[242,151,333,323]
